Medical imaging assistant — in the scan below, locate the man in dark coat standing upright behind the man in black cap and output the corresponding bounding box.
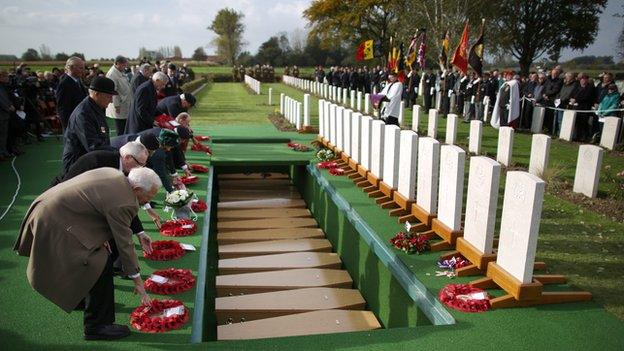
[55,56,87,130]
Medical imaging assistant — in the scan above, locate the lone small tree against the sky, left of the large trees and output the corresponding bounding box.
[208,8,245,65]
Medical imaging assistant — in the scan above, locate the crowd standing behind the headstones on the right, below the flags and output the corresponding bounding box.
[314,66,624,142]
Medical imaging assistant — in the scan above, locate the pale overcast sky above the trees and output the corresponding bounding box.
[0,0,624,60]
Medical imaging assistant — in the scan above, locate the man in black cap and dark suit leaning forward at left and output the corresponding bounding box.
[63,76,117,171]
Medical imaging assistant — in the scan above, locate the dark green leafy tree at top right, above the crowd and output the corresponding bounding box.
[490,0,607,74]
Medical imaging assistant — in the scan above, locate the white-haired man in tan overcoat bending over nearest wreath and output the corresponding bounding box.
[14,168,161,340]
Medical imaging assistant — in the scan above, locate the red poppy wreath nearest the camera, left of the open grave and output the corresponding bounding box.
[130,300,189,333]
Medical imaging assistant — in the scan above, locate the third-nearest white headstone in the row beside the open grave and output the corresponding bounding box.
[438,145,466,230]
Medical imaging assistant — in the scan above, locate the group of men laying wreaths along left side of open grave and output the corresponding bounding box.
[9,56,205,340]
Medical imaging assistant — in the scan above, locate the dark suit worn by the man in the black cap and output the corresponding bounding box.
[63,97,110,171]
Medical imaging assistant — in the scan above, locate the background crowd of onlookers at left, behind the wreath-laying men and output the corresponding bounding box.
[0,57,195,161]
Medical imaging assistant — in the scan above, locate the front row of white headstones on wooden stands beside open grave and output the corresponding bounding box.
[319,100,545,283]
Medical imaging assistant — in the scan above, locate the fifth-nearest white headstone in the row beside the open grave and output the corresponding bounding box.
[397,130,418,201]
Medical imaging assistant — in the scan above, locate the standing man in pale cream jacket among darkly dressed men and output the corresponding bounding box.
[106,56,132,135]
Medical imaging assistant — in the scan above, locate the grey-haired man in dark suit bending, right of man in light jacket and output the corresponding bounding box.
[124,72,169,134]
